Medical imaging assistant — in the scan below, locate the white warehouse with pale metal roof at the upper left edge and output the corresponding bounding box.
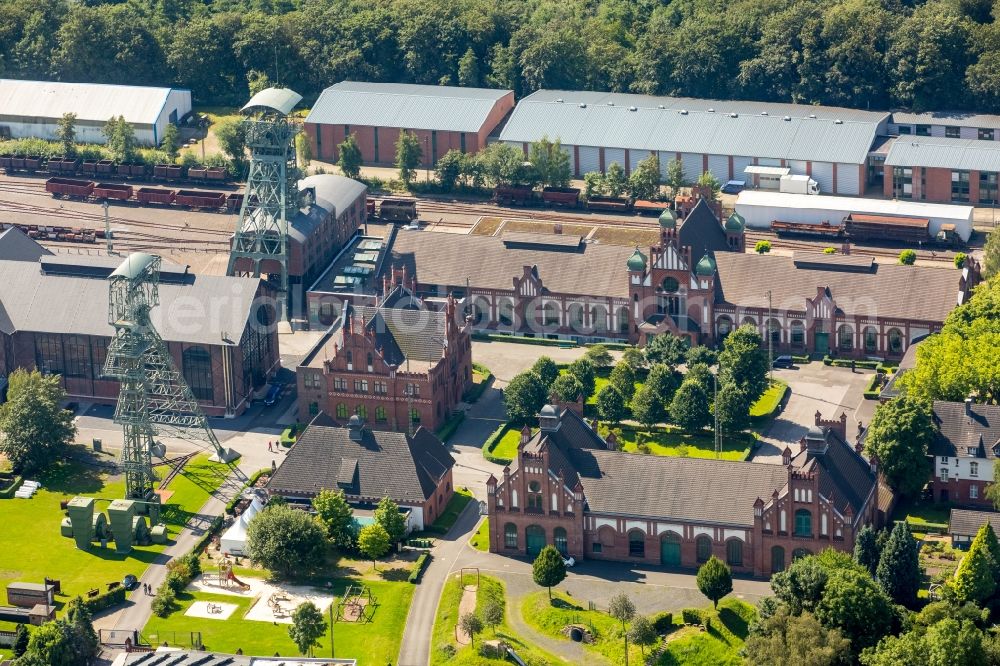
[0,79,191,146]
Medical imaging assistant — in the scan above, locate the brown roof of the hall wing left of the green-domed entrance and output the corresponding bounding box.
[385,231,634,298]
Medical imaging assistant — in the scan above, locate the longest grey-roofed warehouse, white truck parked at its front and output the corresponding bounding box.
[500,90,889,195]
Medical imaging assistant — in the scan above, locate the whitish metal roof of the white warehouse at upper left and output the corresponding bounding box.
[0,79,182,125]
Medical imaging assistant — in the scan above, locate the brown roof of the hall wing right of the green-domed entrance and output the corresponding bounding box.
[715,252,959,322]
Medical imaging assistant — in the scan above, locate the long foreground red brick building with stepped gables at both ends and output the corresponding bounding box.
[486,406,883,576]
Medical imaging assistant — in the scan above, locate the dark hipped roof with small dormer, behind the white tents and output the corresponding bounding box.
[267,413,455,504]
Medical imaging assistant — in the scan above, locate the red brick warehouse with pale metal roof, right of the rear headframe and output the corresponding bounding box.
[305,81,514,167]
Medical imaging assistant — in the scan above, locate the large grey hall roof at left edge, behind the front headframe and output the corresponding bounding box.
[0,235,261,345]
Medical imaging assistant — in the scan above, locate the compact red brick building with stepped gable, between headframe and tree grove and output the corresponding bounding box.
[296,284,472,431]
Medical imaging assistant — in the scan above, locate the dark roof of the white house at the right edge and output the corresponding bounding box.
[930,400,1000,460]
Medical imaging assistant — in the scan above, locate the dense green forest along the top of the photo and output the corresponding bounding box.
[0,0,1000,112]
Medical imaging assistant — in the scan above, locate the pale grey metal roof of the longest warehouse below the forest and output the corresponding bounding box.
[500,90,888,164]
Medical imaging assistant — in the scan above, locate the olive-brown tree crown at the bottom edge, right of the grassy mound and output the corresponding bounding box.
[744,604,851,666]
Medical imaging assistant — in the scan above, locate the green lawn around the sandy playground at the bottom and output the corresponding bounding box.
[142,579,414,666]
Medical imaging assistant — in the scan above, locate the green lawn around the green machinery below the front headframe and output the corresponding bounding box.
[0,448,230,628]
